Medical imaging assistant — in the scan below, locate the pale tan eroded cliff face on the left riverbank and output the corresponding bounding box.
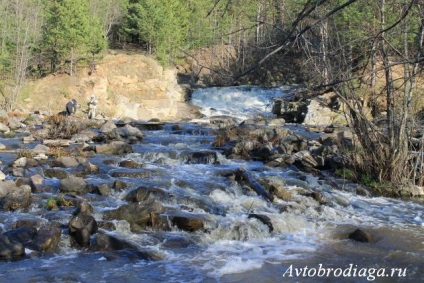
[19,52,202,121]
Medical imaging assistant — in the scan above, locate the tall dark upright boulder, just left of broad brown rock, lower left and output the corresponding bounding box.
[68,213,98,247]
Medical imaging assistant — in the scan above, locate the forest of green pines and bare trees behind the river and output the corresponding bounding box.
[0,0,424,191]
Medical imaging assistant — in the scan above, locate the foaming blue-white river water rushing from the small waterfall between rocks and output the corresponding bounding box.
[0,87,424,282]
